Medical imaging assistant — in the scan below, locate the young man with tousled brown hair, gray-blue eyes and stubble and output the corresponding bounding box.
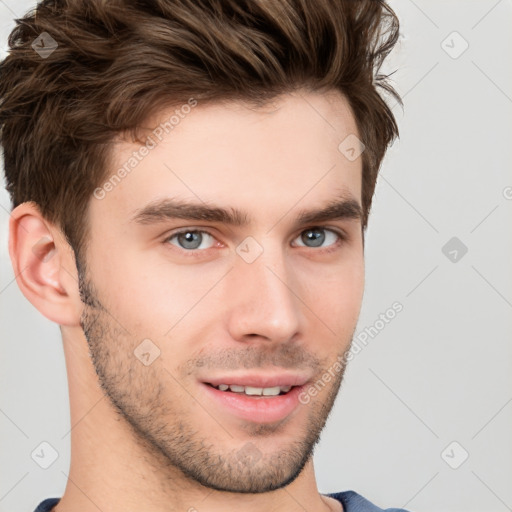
[0,0,408,512]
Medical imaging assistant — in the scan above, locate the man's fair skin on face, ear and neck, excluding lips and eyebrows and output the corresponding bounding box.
[10,91,364,512]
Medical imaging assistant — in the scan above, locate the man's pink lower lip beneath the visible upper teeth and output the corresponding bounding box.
[203,384,304,423]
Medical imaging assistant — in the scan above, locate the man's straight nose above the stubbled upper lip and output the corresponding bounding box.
[225,244,303,343]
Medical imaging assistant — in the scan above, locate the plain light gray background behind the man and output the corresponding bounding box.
[0,0,512,512]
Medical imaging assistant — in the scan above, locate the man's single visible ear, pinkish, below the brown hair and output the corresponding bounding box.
[9,202,82,326]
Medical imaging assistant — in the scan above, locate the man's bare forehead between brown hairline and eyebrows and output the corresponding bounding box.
[91,91,362,227]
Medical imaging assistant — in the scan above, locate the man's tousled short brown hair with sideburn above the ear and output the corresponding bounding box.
[0,0,401,257]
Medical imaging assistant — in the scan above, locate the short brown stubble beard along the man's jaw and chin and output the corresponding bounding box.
[79,272,348,493]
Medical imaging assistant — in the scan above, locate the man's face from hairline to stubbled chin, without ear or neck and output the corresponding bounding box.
[81,93,364,492]
